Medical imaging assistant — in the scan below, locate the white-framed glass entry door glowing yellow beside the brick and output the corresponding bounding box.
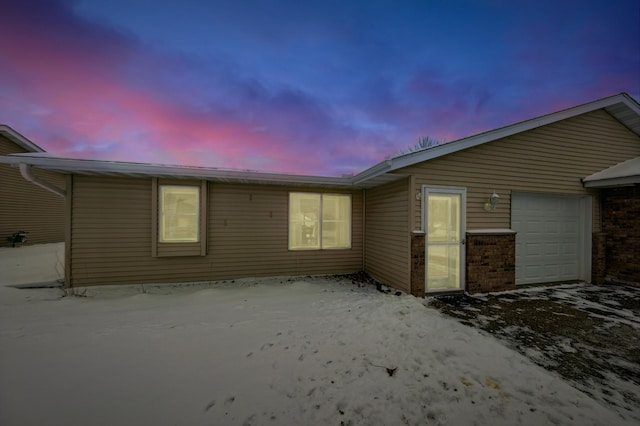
[422,186,466,292]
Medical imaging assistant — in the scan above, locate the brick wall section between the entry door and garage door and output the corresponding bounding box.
[466,230,516,293]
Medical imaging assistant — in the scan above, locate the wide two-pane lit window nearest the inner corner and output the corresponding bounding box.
[289,192,351,250]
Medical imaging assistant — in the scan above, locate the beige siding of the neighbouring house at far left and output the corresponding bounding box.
[0,136,66,247]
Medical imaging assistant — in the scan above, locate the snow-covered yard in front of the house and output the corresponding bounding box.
[0,245,634,426]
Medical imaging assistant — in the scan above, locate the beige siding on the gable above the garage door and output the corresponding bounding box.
[399,110,640,231]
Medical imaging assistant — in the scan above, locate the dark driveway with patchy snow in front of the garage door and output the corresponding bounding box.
[428,284,640,421]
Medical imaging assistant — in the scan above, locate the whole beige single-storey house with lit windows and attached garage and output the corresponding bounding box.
[0,94,640,296]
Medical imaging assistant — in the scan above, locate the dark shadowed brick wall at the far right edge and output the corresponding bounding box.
[602,186,640,285]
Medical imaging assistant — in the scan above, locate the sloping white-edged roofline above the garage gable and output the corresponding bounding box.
[354,93,640,183]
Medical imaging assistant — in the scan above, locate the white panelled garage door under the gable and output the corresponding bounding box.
[511,193,585,284]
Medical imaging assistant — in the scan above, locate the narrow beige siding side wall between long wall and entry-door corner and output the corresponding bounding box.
[364,179,410,291]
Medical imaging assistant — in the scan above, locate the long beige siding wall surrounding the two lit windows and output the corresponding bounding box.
[71,176,362,286]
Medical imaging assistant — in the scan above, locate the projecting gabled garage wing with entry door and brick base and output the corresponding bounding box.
[365,95,640,295]
